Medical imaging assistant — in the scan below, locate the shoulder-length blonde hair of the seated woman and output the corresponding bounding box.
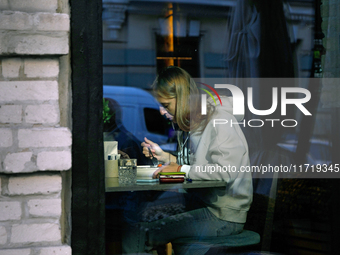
[153,66,211,132]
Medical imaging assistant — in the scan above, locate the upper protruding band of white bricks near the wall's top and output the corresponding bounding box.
[0,11,70,55]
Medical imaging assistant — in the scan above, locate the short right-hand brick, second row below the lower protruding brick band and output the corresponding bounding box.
[27,199,61,217]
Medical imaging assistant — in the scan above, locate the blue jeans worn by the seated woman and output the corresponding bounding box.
[122,192,244,255]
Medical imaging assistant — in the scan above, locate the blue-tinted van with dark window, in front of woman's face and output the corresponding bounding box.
[103,85,169,145]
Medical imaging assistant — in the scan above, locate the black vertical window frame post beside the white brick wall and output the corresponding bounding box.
[70,0,105,255]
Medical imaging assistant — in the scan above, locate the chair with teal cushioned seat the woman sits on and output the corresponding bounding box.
[171,150,290,255]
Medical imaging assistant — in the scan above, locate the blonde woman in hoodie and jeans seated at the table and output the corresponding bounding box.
[123,66,252,252]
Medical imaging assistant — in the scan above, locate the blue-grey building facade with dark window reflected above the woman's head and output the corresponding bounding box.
[103,0,314,89]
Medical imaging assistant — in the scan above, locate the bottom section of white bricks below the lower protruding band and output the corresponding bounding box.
[0,174,67,250]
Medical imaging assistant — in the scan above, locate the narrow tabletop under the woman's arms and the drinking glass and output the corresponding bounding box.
[105,177,226,192]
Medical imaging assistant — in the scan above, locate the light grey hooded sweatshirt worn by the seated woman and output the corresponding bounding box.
[181,97,253,223]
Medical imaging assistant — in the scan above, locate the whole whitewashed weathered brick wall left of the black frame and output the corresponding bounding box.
[0,0,72,255]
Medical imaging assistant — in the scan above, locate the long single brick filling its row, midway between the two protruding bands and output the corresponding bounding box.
[0,81,59,102]
